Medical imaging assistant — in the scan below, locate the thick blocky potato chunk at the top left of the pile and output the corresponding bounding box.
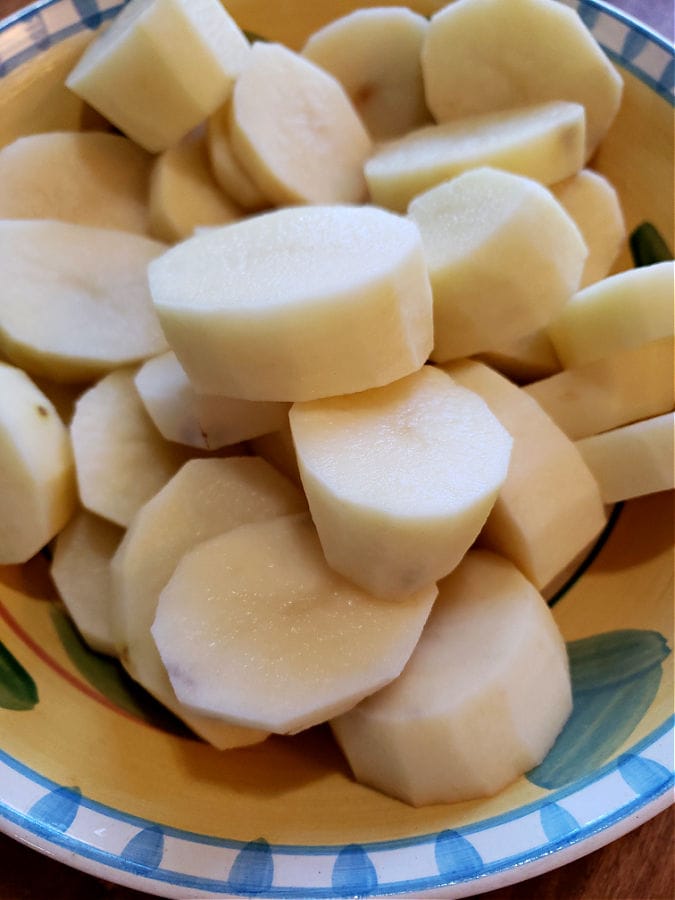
[66,0,250,153]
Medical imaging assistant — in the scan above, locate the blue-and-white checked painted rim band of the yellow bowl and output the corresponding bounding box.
[0,0,675,898]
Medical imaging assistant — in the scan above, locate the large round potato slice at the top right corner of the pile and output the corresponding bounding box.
[422,0,623,159]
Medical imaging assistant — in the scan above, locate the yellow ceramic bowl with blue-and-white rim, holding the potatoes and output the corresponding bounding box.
[0,0,674,900]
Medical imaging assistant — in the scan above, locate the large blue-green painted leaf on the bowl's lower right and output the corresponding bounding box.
[527,629,670,789]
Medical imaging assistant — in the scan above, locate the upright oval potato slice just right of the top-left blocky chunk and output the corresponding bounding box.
[230,42,372,204]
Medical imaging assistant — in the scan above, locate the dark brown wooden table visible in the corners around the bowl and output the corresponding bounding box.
[0,0,675,900]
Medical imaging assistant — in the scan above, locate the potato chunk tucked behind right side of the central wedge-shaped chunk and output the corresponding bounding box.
[444,361,606,591]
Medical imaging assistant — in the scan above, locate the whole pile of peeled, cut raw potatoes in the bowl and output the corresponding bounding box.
[0,0,673,805]
